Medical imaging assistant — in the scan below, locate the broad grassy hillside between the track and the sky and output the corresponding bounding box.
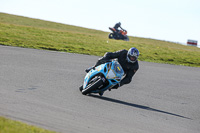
[0,13,200,67]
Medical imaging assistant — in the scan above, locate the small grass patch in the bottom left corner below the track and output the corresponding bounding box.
[0,117,56,133]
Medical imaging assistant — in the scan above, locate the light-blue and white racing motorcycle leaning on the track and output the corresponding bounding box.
[79,60,124,96]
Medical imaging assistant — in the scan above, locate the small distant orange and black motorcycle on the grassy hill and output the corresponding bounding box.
[108,27,129,41]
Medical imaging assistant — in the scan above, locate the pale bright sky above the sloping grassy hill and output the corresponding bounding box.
[0,0,200,45]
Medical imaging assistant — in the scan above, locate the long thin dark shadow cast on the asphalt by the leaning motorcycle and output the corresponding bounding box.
[89,94,192,120]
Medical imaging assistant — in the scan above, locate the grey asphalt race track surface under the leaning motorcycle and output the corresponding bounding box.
[0,46,200,133]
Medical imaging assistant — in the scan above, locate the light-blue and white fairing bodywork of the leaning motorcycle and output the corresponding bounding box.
[83,60,124,93]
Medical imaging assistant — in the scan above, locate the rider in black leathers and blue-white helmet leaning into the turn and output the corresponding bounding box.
[86,47,139,89]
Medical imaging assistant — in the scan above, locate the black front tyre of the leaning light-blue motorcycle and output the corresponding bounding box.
[82,78,103,95]
